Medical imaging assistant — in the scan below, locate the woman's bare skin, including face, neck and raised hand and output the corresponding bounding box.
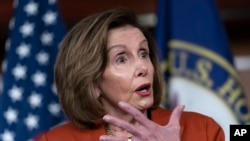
[96,25,183,141]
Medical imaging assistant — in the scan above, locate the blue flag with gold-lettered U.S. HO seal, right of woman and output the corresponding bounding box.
[155,0,250,141]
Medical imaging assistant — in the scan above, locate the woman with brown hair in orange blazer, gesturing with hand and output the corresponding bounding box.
[40,9,224,141]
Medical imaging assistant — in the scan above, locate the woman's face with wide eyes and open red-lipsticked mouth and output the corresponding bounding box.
[99,25,154,113]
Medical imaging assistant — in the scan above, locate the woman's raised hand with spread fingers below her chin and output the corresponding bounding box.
[100,102,184,141]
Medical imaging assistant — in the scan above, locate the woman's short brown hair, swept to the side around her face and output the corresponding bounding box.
[55,9,162,128]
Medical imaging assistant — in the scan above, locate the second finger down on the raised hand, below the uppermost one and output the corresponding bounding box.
[103,115,139,135]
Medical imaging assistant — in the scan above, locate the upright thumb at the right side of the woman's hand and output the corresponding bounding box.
[169,105,185,125]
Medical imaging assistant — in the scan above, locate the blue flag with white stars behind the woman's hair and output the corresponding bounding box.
[0,0,66,141]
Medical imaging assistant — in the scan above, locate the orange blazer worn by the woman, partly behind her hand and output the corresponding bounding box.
[38,108,225,141]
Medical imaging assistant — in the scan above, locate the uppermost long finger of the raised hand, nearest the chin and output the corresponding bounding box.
[118,102,151,127]
